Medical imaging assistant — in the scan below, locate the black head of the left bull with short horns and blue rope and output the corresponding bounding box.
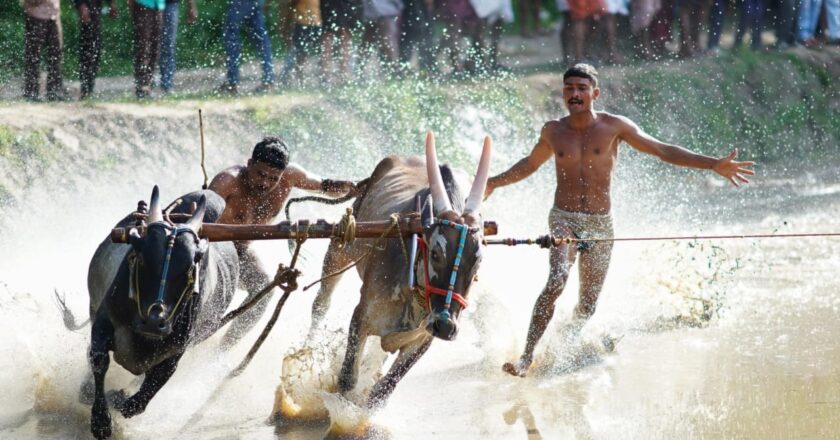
[129,186,207,338]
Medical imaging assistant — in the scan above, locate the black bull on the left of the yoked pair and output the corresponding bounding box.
[76,187,239,438]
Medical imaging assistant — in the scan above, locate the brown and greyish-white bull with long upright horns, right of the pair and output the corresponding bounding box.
[313,133,491,407]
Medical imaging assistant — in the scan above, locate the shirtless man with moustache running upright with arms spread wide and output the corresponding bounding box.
[486,64,755,376]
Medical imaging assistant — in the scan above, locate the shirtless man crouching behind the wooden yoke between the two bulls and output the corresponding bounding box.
[210,137,356,345]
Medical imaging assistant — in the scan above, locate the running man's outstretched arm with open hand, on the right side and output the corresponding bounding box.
[618,116,755,186]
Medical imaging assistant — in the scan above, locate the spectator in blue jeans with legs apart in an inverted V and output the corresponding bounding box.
[219,0,274,94]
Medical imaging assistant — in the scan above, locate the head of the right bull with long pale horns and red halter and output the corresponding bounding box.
[420,133,491,340]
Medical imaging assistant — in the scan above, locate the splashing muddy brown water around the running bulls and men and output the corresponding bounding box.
[0,134,840,439]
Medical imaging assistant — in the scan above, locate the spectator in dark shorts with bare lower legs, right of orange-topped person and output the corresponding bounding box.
[321,0,362,82]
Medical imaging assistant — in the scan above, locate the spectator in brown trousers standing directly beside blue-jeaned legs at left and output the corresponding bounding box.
[131,0,166,99]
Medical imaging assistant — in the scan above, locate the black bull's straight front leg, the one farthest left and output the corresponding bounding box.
[88,317,114,439]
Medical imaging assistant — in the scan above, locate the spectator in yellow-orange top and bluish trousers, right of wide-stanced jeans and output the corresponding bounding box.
[280,0,321,85]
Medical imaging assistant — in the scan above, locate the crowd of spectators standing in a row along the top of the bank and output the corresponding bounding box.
[20,0,840,100]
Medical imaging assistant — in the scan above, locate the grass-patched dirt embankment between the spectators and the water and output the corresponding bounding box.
[0,50,840,228]
